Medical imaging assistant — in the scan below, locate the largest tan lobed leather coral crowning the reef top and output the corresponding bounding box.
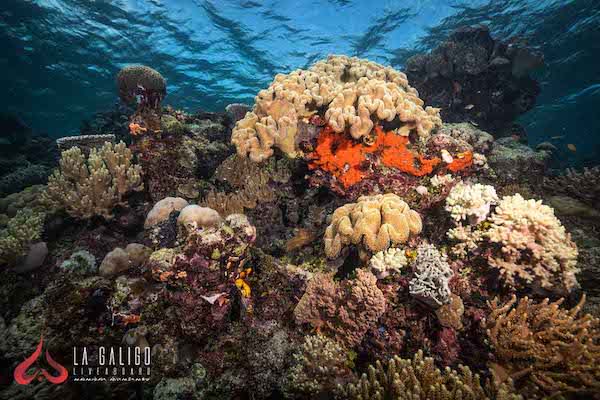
[231,56,442,162]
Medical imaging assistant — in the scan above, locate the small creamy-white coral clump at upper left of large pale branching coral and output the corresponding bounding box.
[446,182,498,224]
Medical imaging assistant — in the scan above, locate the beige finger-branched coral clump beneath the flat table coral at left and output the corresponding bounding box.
[46,142,143,219]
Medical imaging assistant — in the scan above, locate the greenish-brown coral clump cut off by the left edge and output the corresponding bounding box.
[0,209,45,265]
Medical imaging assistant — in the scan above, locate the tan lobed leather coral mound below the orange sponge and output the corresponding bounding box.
[324,193,423,258]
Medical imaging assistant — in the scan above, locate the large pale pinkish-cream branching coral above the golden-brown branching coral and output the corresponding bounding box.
[486,193,578,292]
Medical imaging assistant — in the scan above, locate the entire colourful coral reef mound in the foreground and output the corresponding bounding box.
[0,39,600,400]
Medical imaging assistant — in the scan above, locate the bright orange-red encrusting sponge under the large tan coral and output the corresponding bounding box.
[308,125,446,188]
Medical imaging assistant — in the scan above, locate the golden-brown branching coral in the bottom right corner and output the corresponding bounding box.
[486,295,600,398]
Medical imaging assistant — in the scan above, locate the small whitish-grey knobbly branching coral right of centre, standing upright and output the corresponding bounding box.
[409,243,453,308]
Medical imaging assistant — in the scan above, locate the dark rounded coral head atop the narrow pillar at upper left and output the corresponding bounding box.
[117,65,167,104]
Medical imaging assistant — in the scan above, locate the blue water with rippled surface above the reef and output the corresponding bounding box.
[0,0,600,164]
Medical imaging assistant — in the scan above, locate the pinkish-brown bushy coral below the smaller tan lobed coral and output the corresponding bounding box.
[294,269,386,348]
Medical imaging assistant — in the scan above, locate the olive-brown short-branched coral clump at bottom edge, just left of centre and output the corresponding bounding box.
[286,335,354,398]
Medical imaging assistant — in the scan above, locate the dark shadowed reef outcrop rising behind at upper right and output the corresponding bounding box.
[406,26,543,136]
